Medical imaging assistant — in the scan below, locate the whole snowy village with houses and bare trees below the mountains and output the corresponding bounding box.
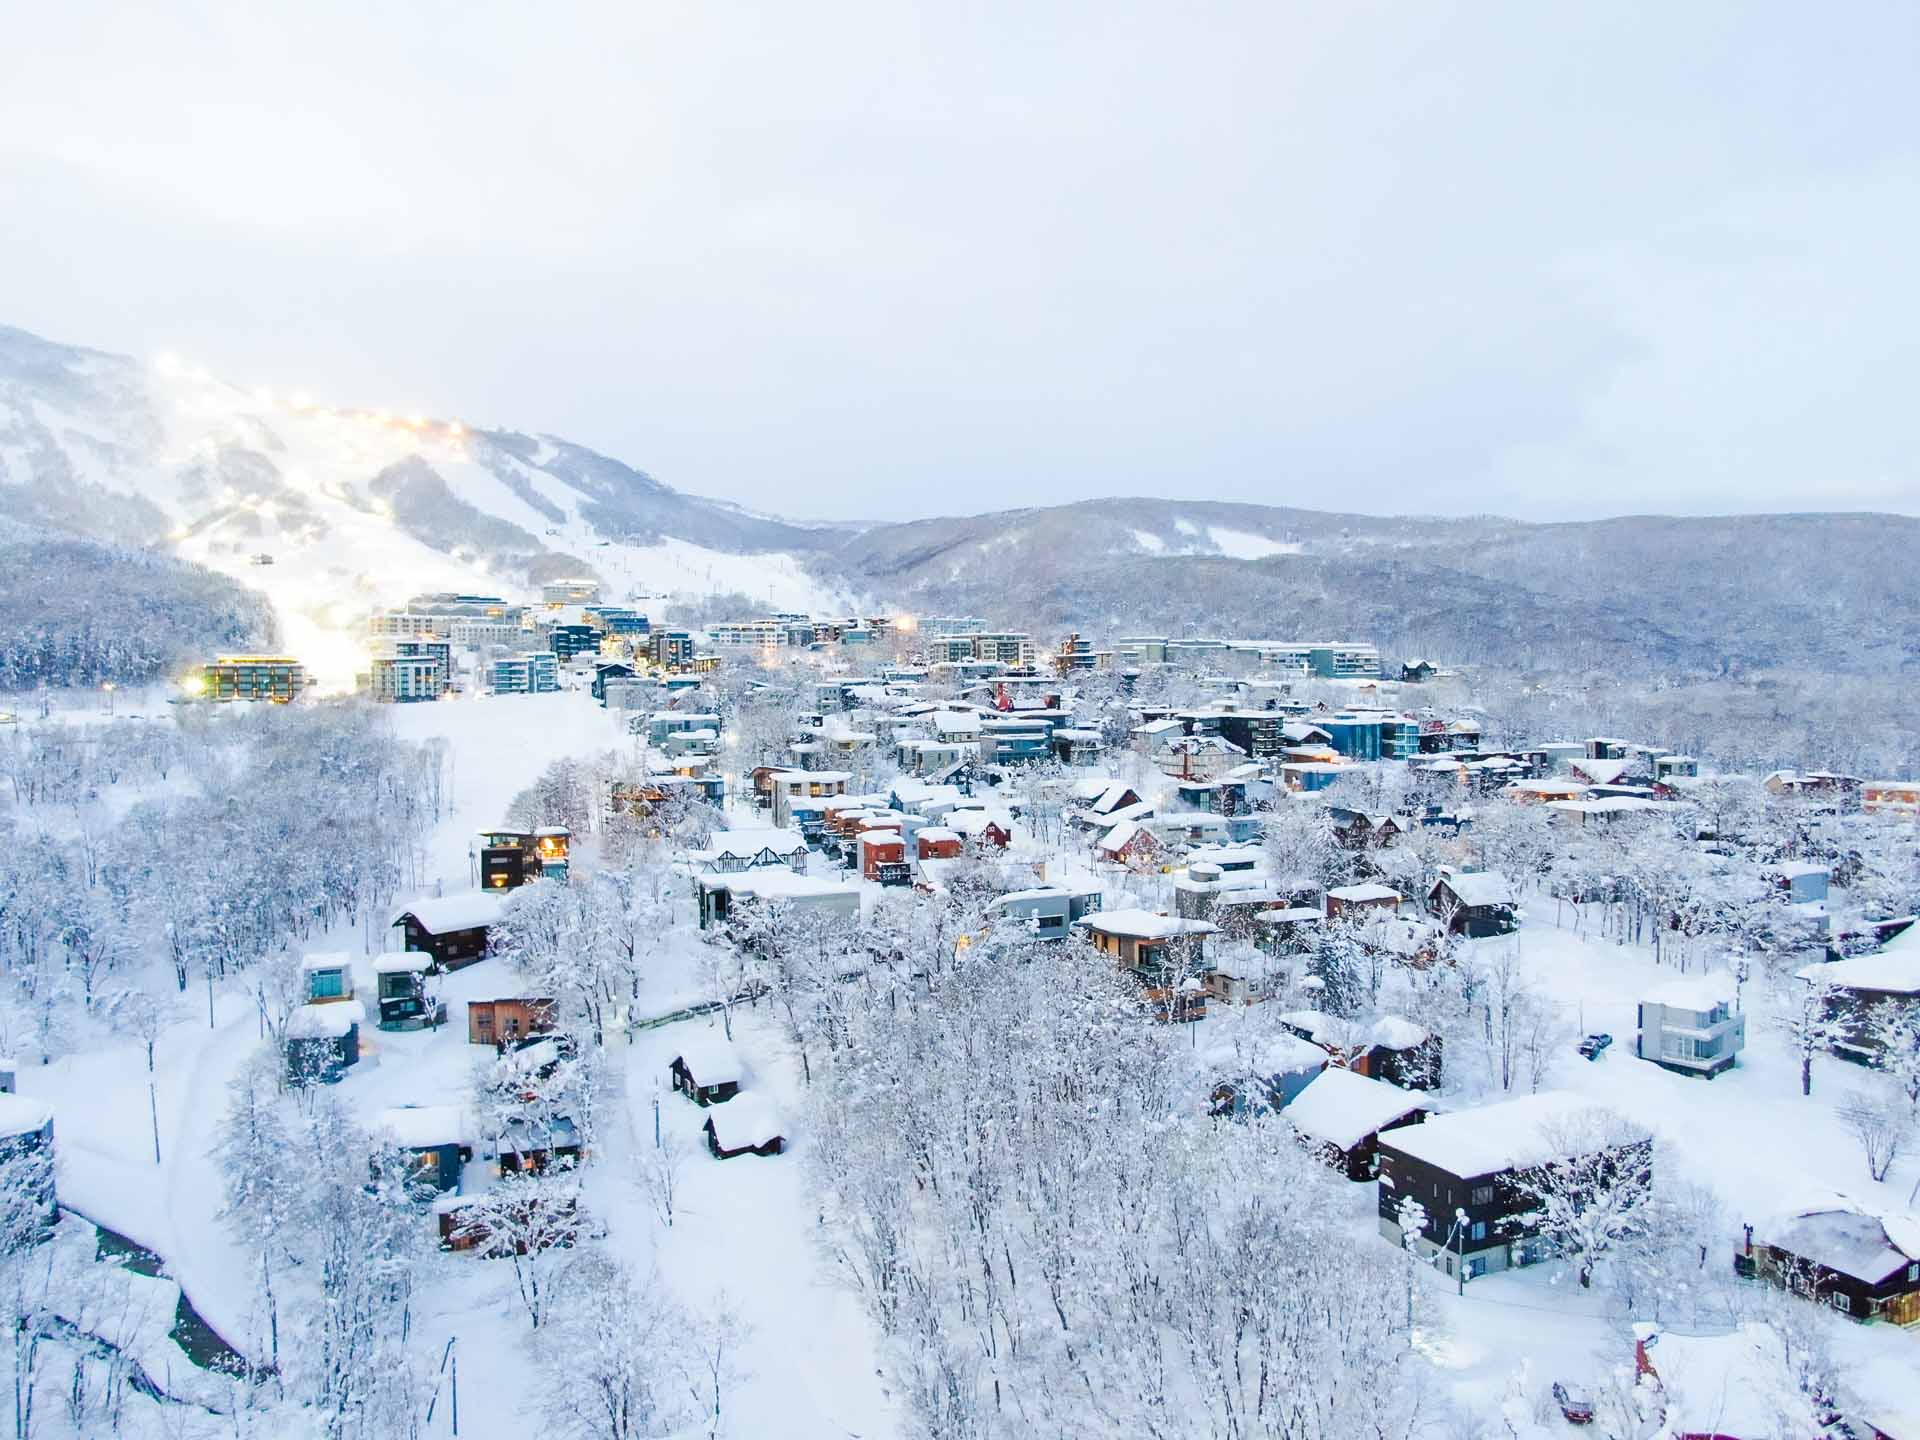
[0,599,1920,1440]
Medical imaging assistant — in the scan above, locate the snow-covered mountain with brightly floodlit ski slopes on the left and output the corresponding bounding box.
[0,328,845,684]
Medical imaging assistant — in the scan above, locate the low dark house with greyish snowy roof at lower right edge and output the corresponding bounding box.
[1734,1196,1920,1325]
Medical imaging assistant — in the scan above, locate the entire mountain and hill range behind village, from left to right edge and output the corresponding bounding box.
[0,328,1920,680]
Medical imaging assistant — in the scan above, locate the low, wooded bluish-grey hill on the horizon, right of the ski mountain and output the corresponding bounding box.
[814,499,1920,674]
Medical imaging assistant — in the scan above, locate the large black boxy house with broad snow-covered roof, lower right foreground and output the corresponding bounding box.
[1379,1091,1653,1277]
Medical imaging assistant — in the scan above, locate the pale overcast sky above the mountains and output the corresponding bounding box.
[0,0,1920,518]
